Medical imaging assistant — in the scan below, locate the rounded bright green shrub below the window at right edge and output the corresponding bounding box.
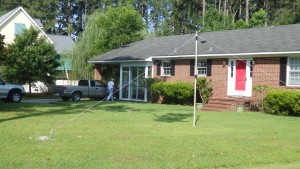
[264,89,300,116]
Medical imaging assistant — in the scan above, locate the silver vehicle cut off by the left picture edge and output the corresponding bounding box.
[0,78,25,103]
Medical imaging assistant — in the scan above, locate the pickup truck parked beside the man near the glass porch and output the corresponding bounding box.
[53,80,108,101]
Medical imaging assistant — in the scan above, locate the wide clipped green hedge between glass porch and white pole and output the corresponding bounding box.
[151,82,194,104]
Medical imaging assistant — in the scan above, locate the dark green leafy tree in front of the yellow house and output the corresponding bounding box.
[0,27,59,88]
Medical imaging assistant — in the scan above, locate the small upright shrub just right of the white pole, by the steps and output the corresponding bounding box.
[196,77,212,103]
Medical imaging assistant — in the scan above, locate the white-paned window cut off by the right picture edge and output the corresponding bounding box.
[288,57,300,85]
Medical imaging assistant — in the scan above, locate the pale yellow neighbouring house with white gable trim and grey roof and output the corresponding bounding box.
[0,7,74,91]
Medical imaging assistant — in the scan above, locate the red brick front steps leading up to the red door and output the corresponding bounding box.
[201,97,250,111]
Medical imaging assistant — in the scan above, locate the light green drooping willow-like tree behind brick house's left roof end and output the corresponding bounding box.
[68,5,145,79]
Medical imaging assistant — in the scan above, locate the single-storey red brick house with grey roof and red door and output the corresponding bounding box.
[90,24,300,105]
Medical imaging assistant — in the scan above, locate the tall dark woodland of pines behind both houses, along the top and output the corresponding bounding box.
[0,0,300,39]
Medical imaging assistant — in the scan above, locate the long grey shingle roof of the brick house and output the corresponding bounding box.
[90,24,300,63]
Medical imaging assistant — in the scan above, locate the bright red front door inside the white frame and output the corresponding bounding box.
[235,60,246,91]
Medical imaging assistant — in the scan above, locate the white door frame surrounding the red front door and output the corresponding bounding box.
[227,58,252,97]
